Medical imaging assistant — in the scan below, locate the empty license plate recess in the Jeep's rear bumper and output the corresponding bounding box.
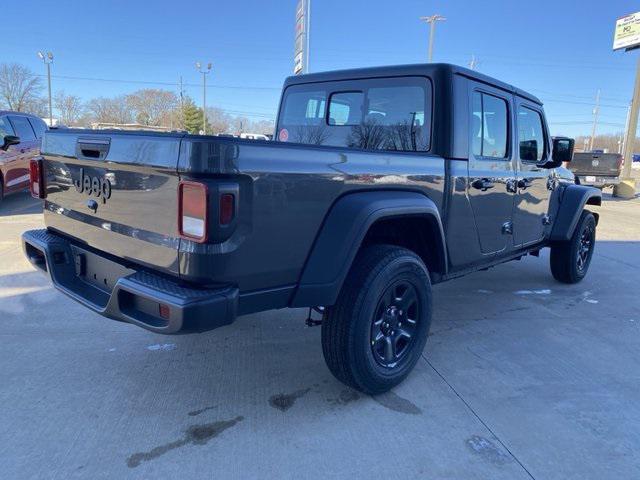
[71,246,135,293]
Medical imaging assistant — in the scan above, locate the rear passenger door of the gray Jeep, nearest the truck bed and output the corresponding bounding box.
[467,84,516,256]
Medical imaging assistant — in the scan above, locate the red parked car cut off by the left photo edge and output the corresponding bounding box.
[0,110,48,202]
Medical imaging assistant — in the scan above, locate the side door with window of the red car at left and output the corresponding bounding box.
[5,115,39,192]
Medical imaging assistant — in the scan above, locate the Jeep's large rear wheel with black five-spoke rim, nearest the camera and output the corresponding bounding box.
[322,245,431,395]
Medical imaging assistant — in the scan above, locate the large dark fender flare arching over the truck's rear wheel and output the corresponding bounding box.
[291,190,448,307]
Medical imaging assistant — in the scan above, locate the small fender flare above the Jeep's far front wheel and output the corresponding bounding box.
[549,185,602,242]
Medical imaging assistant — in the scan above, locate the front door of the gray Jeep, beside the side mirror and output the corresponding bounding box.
[513,98,553,247]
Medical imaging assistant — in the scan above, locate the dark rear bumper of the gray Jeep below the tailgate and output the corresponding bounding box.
[22,230,238,334]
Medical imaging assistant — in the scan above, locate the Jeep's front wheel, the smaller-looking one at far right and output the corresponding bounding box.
[551,210,596,283]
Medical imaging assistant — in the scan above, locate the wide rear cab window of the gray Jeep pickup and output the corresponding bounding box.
[278,77,432,152]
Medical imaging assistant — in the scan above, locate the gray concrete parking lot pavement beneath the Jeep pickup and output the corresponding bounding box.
[0,189,640,479]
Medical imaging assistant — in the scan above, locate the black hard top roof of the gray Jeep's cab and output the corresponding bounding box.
[284,63,542,105]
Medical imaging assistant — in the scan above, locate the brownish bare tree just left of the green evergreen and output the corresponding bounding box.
[127,88,178,127]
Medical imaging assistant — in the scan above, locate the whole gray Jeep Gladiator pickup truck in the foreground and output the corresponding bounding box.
[23,64,601,394]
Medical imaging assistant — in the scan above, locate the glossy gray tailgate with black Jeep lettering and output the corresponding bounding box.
[42,130,183,275]
